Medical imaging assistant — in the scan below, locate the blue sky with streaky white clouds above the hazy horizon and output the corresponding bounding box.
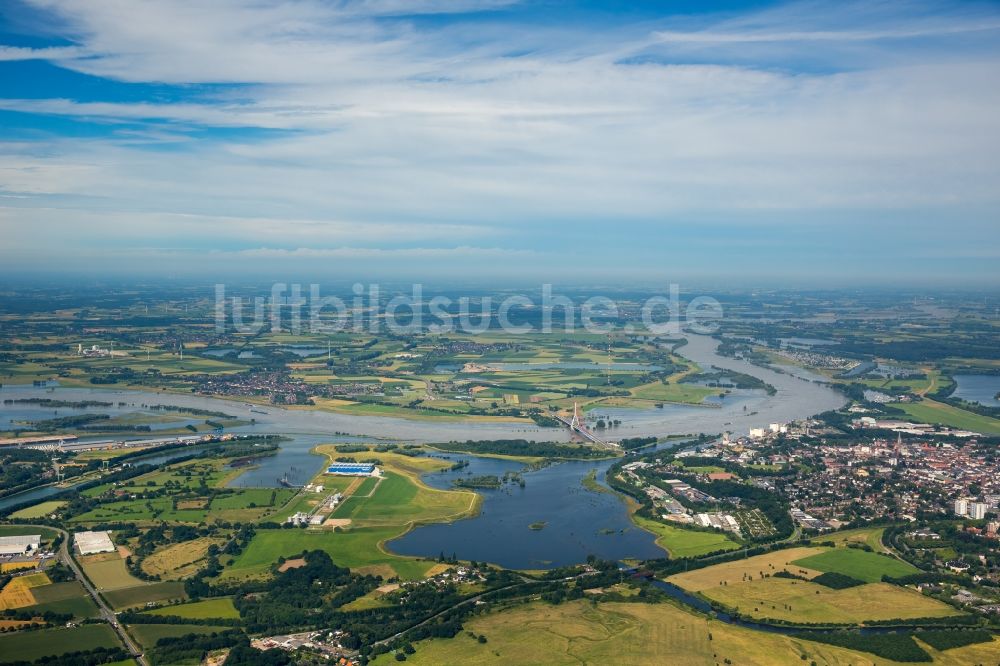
[0,0,1000,287]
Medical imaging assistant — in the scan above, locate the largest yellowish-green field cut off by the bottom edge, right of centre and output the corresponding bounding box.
[374,600,952,666]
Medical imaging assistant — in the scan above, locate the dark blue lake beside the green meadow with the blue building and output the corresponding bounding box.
[387,442,677,569]
